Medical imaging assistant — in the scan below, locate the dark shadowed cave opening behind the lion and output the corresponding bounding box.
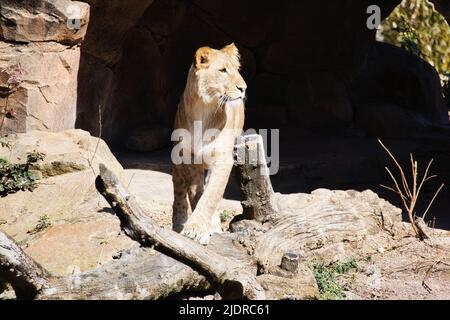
[77,0,450,230]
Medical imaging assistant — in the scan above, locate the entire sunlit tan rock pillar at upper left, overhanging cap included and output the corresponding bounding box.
[0,0,89,133]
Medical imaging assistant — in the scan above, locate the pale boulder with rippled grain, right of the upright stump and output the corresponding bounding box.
[254,189,403,271]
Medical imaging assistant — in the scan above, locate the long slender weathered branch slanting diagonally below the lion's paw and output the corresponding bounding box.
[96,165,265,299]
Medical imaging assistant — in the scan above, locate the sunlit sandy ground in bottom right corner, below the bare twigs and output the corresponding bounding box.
[339,232,450,300]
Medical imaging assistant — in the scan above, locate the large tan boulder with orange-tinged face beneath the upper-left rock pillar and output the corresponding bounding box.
[0,130,133,275]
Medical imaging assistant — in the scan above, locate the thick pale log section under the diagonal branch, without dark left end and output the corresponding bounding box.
[37,248,211,300]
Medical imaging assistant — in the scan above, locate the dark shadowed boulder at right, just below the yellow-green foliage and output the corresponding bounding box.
[352,43,449,125]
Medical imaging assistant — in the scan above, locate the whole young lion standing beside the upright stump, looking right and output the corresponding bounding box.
[172,44,247,244]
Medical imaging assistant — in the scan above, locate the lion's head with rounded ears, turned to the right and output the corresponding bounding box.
[188,43,247,104]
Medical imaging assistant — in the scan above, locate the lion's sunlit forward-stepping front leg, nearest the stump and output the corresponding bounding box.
[182,163,233,244]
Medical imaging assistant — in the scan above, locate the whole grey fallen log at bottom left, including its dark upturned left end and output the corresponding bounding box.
[0,232,212,300]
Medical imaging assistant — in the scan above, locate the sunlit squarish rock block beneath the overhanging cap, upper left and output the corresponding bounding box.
[0,41,80,133]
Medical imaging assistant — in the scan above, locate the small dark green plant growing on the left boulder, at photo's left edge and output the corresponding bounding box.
[0,151,45,197]
